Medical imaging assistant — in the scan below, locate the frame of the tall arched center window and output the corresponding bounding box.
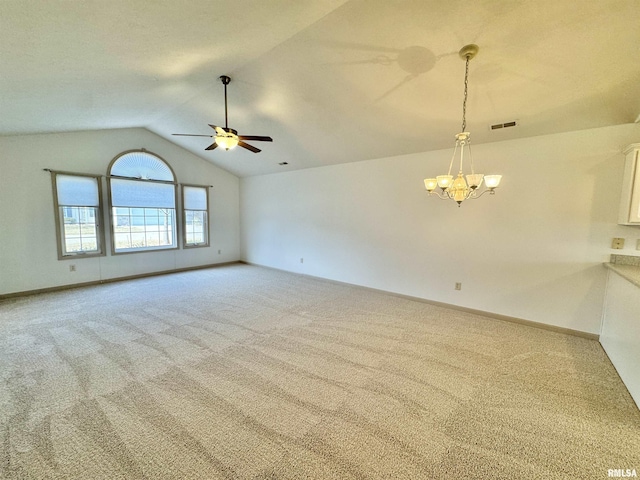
[106,148,180,256]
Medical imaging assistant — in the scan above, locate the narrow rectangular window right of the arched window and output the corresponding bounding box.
[182,185,209,247]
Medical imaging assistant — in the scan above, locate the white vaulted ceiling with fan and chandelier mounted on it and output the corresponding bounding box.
[0,0,640,176]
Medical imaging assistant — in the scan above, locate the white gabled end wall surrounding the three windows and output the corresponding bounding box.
[0,128,240,295]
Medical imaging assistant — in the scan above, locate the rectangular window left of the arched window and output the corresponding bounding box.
[51,171,104,259]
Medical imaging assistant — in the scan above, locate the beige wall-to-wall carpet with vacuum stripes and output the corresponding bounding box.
[0,264,640,479]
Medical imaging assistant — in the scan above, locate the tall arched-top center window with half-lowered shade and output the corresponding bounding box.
[109,150,177,253]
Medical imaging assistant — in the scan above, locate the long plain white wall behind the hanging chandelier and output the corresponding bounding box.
[241,124,640,333]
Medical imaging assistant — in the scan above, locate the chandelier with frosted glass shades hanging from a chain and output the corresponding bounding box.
[424,44,502,206]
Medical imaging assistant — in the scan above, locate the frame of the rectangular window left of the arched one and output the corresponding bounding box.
[49,170,107,260]
